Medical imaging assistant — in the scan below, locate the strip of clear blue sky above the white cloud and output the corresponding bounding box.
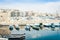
[0,0,60,3]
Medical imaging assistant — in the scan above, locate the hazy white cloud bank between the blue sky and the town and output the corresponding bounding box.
[0,2,60,13]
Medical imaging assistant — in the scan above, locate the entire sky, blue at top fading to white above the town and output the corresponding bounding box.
[0,0,60,13]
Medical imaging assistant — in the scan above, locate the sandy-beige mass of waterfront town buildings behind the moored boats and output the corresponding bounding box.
[0,9,60,25]
